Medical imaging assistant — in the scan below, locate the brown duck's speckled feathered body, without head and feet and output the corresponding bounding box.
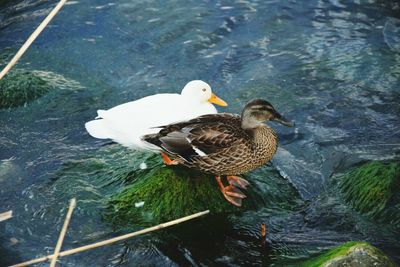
[143,113,278,175]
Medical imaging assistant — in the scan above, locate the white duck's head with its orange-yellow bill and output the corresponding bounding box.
[181,80,228,107]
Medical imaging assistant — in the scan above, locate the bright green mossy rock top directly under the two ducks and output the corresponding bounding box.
[106,167,254,228]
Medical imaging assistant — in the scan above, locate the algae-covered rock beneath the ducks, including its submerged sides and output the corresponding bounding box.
[52,145,296,232]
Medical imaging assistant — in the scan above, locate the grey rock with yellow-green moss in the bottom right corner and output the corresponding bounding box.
[301,241,397,267]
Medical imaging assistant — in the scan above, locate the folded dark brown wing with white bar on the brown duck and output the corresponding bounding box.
[144,113,245,161]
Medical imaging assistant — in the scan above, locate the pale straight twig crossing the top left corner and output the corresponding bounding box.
[0,0,67,80]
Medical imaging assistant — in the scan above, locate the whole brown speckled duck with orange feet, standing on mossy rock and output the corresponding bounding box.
[142,99,293,206]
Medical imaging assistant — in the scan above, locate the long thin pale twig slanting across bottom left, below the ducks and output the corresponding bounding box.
[10,210,210,267]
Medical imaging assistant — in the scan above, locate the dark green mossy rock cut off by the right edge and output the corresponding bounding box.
[339,161,400,224]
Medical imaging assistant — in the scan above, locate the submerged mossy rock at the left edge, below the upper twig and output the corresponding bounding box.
[0,70,53,109]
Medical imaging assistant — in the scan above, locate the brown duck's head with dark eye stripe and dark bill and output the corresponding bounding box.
[242,99,294,129]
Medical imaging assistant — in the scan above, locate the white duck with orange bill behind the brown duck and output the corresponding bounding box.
[85,80,227,151]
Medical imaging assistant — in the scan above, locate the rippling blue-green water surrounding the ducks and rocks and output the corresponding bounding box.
[0,0,400,266]
